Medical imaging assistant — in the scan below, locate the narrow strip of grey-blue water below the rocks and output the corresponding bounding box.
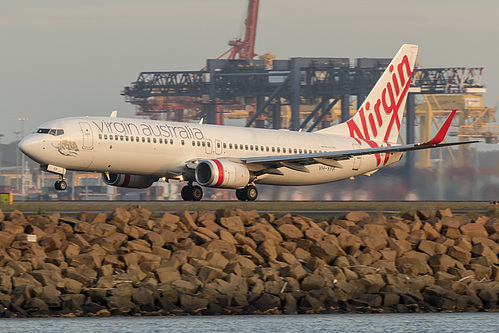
[0,313,499,333]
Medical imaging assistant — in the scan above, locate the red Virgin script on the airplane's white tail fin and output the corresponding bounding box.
[347,55,413,142]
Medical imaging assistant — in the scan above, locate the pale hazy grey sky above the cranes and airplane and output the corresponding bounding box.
[0,0,499,143]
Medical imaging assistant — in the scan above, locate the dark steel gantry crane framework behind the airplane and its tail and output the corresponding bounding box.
[122,58,484,136]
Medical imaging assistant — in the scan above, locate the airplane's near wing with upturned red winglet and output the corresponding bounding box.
[242,110,480,174]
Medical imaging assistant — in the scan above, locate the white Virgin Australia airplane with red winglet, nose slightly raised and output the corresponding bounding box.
[19,44,478,201]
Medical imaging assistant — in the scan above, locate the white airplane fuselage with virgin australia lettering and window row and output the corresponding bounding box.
[19,117,402,185]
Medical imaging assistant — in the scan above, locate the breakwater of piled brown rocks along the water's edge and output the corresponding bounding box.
[0,206,499,317]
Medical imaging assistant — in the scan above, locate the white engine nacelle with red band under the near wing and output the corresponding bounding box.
[195,160,251,189]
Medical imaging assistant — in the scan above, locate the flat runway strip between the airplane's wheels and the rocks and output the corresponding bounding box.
[0,201,497,216]
